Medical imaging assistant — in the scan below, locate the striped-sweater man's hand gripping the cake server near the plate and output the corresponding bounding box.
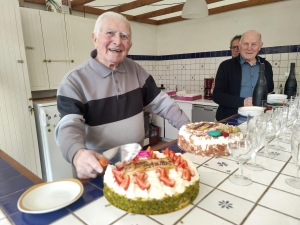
[73,149,105,179]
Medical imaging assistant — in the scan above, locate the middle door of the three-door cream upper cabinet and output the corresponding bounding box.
[39,11,70,89]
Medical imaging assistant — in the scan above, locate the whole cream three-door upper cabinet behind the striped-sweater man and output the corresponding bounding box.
[20,8,94,91]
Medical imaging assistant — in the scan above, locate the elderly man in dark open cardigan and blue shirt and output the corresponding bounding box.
[213,30,274,121]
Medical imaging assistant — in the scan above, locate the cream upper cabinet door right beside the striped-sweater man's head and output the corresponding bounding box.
[65,15,96,69]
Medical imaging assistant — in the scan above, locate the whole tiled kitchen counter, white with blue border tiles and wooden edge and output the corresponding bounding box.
[0,115,300,225]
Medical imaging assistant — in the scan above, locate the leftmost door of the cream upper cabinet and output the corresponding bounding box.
[20,8,49,91]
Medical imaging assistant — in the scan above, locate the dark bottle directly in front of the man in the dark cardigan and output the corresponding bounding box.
[252,63,268,106]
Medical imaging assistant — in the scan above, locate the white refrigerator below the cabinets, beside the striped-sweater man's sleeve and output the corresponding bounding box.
[33,100,76,182]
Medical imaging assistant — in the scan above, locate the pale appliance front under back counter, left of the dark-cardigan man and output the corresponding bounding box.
[192,104,218,123]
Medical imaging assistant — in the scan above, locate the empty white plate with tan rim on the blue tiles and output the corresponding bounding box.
[18,179,83,214]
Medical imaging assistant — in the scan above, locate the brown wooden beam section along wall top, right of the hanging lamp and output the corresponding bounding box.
[208,0,285,15]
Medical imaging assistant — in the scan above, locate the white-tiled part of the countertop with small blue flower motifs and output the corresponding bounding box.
[46,127,300,225]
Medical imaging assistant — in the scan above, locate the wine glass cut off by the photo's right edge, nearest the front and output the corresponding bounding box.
[285,126,300,189]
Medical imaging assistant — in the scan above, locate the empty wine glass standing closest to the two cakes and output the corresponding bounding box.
[227,130,256,186]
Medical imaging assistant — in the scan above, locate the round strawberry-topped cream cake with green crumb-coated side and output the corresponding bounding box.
[103,147,199,215]
